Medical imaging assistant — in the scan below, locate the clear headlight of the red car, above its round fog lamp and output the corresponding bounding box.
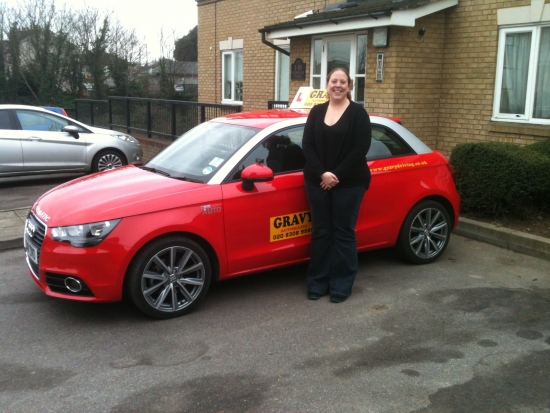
[52,219,120,248]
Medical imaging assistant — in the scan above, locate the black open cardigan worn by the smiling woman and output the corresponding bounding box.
[302,102,371,188]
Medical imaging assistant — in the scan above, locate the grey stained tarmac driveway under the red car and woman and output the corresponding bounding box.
[0,236,550,413]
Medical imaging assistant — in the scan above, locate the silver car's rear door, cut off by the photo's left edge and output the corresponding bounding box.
[0,110,23,175]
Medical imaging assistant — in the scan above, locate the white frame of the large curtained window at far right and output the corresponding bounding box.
[491,24,550,125]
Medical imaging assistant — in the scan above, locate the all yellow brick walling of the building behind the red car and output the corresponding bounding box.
[198,0,550,155]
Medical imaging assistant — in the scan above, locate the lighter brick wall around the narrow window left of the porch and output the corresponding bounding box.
[198,0,338,110]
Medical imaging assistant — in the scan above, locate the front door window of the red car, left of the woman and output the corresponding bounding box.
[230,125,306,179]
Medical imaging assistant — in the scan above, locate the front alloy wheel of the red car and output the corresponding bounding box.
[126,236,212,318]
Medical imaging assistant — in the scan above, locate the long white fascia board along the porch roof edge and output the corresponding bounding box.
[267,0,458,39]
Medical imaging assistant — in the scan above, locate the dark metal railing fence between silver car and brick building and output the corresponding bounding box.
[75,96,242,140]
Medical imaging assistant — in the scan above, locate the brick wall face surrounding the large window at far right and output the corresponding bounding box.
[437,0,550,154]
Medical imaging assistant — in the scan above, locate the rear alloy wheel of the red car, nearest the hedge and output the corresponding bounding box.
[402,200,452,264]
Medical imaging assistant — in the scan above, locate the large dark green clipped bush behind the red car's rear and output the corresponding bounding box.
[450,142,550,216]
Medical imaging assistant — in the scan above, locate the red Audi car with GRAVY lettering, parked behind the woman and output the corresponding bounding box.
[24,109,460,318]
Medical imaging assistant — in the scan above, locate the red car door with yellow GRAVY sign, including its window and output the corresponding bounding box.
[222,125,311,275]
